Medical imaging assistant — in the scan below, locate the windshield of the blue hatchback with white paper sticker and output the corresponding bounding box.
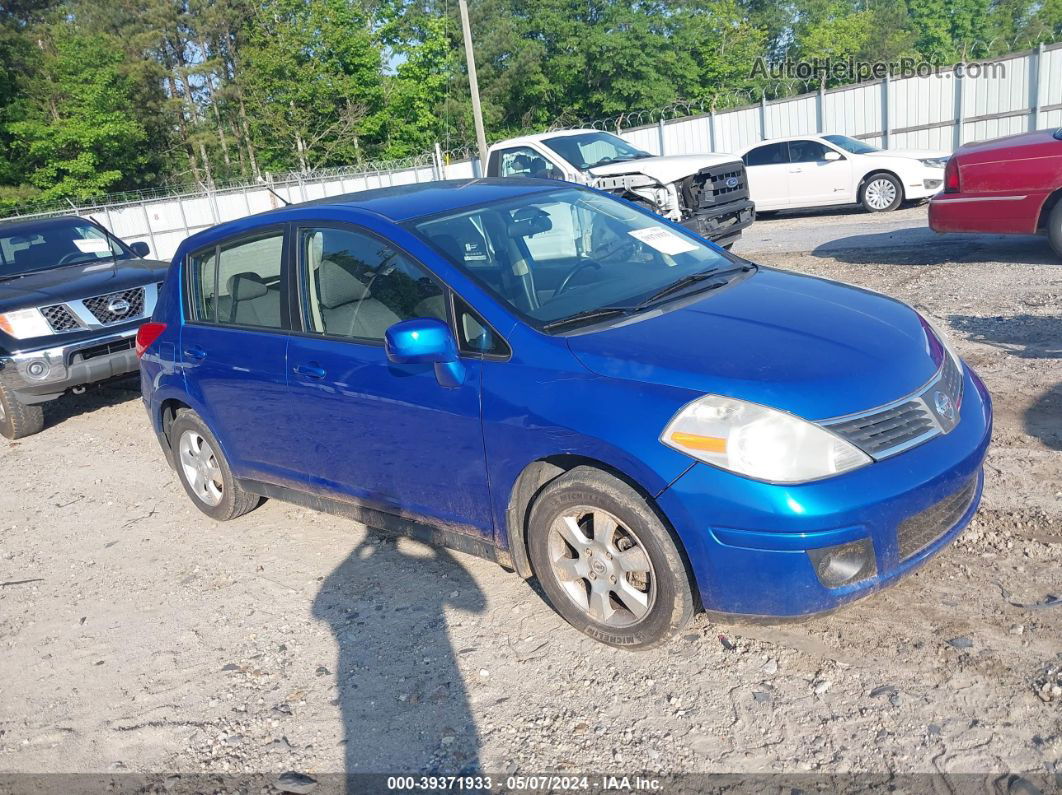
[410,188,736,328]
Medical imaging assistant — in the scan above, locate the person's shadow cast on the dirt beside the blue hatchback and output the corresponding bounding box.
[313,531,486,792]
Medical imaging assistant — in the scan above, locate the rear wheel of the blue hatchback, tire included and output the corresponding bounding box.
[170,409,261,521]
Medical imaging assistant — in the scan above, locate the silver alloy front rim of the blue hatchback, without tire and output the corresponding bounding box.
[548,506,656,627]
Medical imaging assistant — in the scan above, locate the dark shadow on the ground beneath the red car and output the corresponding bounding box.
[811,226,1062,266]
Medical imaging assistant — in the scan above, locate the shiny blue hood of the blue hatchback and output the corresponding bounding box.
[568,269,938,419]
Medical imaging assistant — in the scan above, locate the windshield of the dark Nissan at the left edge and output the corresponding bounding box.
[0,219,132,278]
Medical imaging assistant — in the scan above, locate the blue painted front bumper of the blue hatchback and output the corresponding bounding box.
[657,368,992,618]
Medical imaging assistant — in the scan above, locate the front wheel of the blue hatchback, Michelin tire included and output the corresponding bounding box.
[528,466,695,651]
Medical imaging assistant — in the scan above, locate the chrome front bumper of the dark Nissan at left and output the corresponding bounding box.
[0,328,137,404]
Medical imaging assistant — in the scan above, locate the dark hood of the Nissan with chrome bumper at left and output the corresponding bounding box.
[0,259,169,312]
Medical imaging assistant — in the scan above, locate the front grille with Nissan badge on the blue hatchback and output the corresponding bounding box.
[819,353,962,460]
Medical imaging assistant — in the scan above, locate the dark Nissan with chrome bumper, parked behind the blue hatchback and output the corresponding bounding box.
[0,218,169,439]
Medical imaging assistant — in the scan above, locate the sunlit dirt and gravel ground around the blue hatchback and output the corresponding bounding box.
[0,201,1062,792]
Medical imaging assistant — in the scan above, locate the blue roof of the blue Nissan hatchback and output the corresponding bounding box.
[182,177,573,247]
